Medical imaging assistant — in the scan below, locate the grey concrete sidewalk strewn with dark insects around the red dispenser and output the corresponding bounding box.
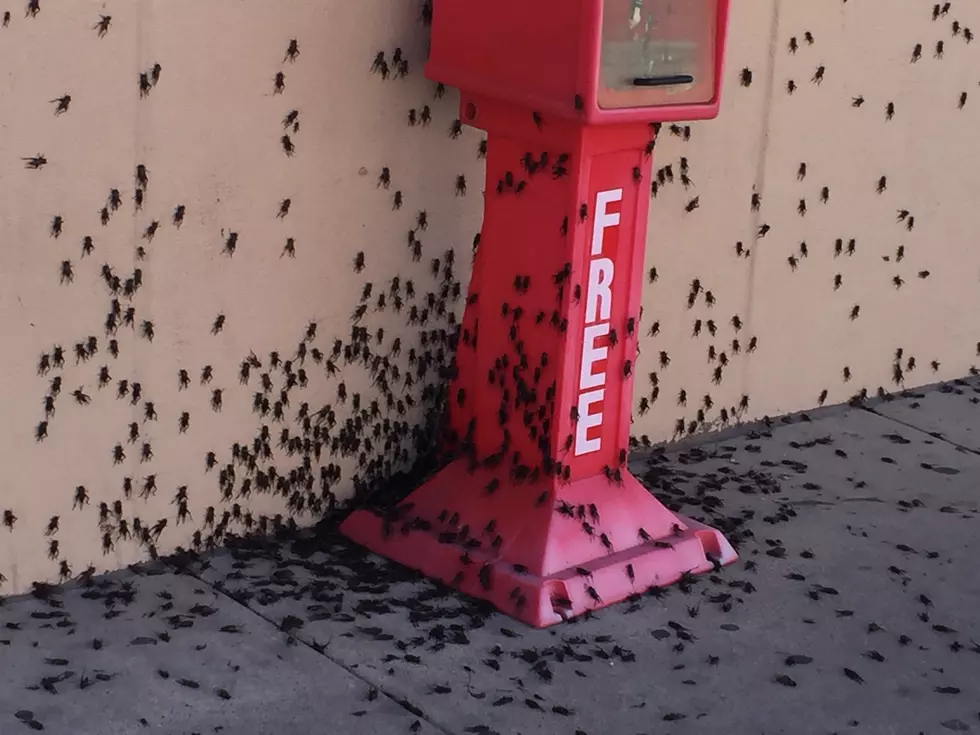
[0,381,980,735]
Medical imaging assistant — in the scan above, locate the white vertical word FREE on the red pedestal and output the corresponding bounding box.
[575,189,623,457]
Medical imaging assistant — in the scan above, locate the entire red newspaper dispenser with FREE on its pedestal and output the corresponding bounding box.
[342,0,736,627]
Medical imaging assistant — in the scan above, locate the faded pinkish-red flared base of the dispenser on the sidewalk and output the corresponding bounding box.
[340,461,737,628]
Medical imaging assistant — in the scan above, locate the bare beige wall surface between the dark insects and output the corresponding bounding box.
[0,0,980,592]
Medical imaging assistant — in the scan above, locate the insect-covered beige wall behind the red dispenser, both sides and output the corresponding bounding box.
[0,0,980,592]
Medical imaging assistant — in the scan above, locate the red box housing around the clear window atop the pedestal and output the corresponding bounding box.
[426,0,730,125]
